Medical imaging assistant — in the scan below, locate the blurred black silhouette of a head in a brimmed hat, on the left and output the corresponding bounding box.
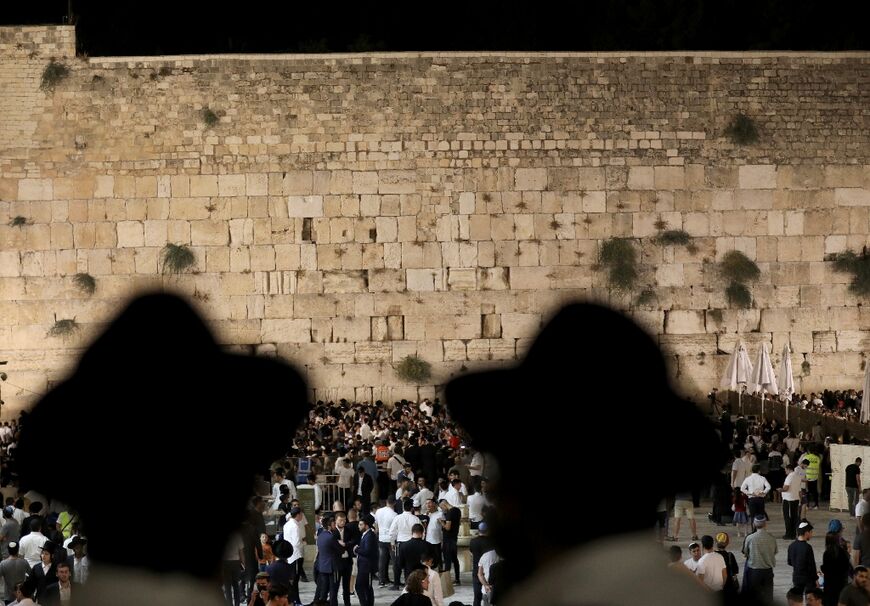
[18,294,306,578]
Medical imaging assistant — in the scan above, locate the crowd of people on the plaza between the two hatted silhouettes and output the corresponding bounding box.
[235,399,499,606]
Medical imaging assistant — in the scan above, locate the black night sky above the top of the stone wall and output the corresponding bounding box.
[0,0,870,56]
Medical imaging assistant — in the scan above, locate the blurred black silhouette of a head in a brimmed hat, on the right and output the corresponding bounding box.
[445,303,726,557]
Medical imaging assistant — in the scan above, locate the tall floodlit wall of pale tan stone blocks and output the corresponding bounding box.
[0,27,870,414]
